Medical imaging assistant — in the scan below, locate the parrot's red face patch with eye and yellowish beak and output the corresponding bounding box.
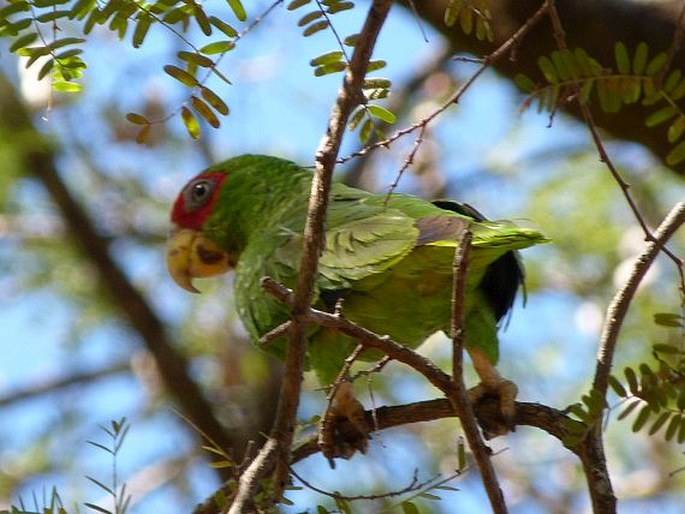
[166,170,236,293]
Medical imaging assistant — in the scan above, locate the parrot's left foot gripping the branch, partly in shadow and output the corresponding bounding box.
[319,382,370,468]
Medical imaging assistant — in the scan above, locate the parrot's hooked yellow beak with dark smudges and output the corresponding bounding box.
[166,228,234,293]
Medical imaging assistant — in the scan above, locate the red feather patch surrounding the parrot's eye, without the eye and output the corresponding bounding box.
[171,172,228,230]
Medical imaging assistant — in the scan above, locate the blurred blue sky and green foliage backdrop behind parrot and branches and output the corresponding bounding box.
[0,2,685,513]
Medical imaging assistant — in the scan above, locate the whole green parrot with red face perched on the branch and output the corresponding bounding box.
[166,155,548,454]
